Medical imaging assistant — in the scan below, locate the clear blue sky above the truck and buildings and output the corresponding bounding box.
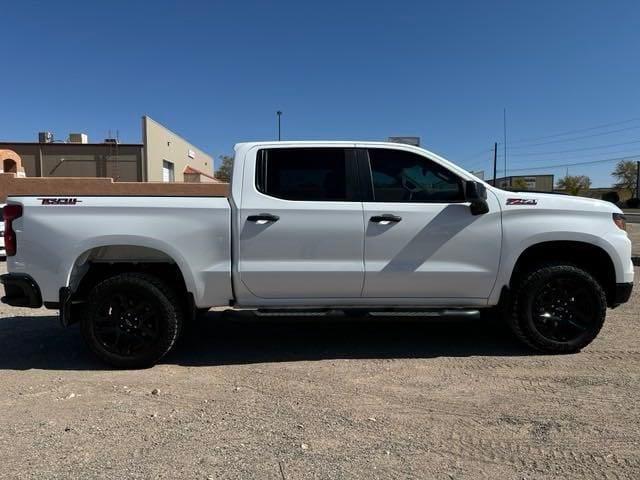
[0,0,640,186]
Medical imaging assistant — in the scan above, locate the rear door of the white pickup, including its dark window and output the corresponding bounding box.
[238,147,364,304]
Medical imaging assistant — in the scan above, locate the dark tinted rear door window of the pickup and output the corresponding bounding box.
[256,148,348,201]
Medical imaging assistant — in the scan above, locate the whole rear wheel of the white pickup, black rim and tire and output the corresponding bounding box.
[81,273,182,368]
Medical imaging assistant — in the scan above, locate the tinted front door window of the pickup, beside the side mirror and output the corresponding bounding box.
[369,148,464,203]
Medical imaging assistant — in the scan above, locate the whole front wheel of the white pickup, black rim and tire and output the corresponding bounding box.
[506,264,607,353]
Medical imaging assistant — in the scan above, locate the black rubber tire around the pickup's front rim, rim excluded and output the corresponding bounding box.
[505,263,607,353]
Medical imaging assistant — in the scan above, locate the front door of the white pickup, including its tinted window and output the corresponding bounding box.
[361,148,501,304]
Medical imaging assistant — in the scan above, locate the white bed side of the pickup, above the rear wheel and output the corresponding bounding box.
[7,194,232,307]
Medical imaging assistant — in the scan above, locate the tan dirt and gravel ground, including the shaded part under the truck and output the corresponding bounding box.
[0,269,640,480]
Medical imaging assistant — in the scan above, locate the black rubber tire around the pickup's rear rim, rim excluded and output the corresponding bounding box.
[80,273,183,368]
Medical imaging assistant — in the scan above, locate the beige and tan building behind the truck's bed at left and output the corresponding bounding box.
[0,116,217,183]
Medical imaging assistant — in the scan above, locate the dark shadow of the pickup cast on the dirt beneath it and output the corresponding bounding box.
[0,312,532,370]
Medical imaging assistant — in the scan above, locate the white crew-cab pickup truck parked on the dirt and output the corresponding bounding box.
[2,142,634,367]
